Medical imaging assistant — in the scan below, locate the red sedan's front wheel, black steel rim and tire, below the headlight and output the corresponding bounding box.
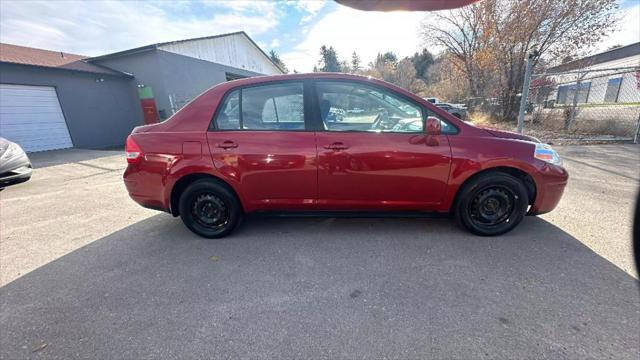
[454,171,529,236]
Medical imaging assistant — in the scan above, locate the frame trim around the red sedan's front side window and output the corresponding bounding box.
[310,78,460,136]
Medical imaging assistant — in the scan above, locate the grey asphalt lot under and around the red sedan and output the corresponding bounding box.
[0,145,640,359]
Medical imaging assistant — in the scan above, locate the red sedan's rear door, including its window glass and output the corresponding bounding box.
[207,81,317,211]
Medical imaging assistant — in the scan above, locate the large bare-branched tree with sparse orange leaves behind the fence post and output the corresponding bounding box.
[423,0,617,119]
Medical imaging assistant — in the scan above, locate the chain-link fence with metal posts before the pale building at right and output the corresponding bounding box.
[525,67,640,142]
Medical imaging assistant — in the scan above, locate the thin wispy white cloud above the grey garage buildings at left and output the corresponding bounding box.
[0,0,280,56]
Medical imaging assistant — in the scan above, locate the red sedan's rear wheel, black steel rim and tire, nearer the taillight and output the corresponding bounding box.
[179,179,242,239]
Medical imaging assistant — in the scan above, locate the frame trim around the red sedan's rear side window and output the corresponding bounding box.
[207,79,315,132]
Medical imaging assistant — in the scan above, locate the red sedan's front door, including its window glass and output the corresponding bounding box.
[314,80,451,210]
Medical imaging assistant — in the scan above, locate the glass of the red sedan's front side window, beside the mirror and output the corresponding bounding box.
[316,81,424,132]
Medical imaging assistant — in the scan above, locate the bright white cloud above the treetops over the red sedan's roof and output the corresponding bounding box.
[282,6,424,72]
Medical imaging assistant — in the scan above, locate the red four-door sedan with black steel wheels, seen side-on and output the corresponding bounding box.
[124,73,568,238]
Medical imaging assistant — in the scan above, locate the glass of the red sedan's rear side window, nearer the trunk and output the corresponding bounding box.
[215,82,305,130]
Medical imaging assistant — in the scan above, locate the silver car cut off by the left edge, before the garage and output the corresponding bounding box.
[0,137,32,190]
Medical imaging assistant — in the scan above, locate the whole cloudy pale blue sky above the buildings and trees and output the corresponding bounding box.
[0,0,640,72]
